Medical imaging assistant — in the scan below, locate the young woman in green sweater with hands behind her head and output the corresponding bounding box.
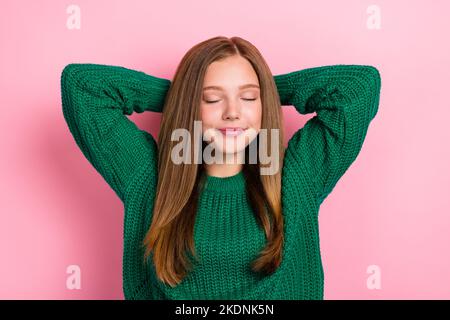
[61,37,381,299]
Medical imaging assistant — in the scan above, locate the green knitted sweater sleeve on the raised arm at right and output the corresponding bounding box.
[274,65,381,204]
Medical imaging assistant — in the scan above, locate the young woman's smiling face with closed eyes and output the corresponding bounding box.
[200,55,262,157]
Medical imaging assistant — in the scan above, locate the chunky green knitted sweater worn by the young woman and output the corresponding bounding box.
[61,63,381,300]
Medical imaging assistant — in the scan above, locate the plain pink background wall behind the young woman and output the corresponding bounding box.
[0,0,450,299]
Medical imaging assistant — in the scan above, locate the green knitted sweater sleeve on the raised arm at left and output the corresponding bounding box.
[61,63,170,201]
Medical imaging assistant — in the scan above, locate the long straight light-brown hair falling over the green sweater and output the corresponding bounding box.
[143,36,284,287]
